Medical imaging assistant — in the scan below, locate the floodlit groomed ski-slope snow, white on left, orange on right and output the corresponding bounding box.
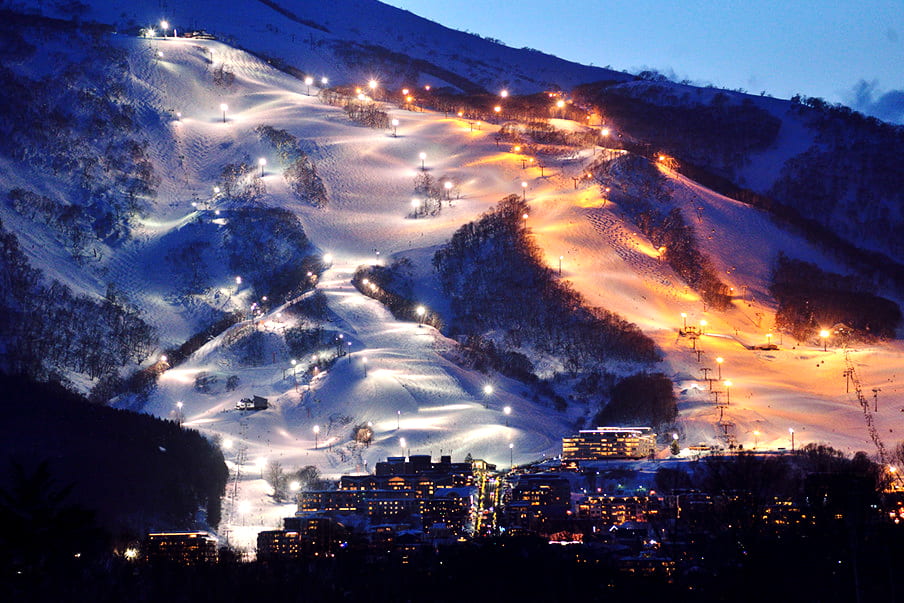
[7,31,904,548]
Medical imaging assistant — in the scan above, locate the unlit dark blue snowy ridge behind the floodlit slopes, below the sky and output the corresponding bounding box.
[31,0,631,94]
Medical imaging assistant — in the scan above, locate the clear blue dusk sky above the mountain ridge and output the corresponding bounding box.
[388,0,904,123]
